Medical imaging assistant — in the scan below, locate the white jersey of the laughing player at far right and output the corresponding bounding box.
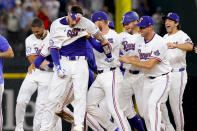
[163,30,192,68]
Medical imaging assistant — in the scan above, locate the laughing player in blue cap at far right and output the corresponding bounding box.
[162,12,193,131]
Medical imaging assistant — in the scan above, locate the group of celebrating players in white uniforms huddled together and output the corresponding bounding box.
[11,6,193,131]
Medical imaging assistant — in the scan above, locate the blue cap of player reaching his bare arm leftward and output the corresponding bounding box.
[136,16,154,28]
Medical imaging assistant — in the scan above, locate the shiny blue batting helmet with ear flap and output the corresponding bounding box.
[121,11,139,24]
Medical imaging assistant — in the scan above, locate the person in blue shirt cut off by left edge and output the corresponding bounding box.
[0,35,14,131]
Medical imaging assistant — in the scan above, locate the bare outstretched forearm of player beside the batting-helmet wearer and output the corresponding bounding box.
[119,55,160,69]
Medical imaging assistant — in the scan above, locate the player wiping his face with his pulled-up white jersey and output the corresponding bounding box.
[41,6,113,131]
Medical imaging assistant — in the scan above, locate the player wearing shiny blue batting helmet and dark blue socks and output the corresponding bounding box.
[119,11,144,131]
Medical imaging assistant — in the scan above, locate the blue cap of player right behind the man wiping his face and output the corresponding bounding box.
[92,11,108,22]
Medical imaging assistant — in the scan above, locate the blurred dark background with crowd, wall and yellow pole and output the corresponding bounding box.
[0,0,197,131]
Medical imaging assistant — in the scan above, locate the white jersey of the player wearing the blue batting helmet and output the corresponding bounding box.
[119,32,141,70]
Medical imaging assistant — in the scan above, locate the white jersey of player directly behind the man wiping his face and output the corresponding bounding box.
[94,29,120,70]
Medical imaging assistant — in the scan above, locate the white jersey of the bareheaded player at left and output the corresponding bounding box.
[25,31,50,56]
